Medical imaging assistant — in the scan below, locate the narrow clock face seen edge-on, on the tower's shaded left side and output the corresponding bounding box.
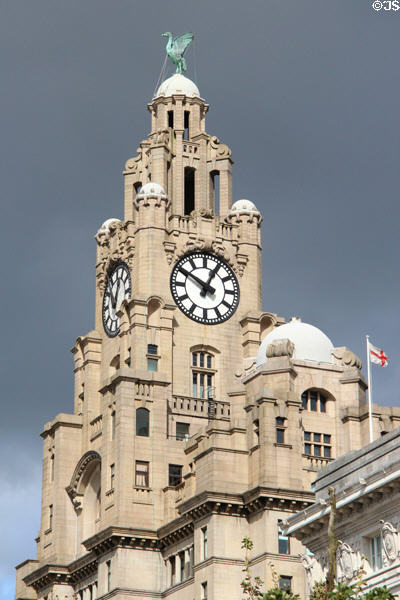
[102,263,132,337]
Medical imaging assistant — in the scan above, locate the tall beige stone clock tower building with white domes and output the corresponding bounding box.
[16,75,400,600]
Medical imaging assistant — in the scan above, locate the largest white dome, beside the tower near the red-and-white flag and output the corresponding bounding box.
[256,317,333,367]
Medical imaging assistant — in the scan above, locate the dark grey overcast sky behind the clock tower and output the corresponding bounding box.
[0,0,400,600]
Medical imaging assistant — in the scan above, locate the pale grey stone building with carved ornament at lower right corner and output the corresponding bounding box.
[284,428,400,597]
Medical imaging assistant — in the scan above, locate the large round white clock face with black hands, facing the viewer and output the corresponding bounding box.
[170,252,240,325]
